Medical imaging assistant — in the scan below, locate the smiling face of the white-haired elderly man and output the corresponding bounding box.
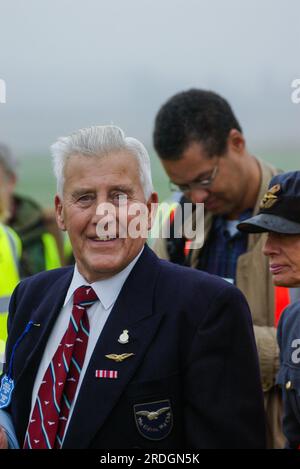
[55,152,157,283]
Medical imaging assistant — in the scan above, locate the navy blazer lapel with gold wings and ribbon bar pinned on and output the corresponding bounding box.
[63,247,163,448]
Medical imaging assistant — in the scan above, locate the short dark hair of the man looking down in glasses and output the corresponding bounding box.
[153,89,242,160]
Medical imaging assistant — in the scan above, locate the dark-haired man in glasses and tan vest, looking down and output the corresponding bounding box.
[154,89,284,448]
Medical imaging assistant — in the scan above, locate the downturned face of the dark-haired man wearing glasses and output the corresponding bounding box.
[161,142,247,214]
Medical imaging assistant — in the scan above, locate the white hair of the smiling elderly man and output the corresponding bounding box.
[51,125,153,200]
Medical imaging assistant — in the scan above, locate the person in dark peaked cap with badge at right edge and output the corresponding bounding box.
[238,171,300,449]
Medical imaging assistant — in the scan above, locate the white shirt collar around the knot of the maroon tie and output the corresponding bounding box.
[64,248,144,309]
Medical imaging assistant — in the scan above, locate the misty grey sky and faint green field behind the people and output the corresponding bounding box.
[0,0,300,204]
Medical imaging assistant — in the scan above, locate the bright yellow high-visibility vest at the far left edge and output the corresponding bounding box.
[0,224,22,372]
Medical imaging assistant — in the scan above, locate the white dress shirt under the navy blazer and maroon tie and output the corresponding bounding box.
[30,249,143,440]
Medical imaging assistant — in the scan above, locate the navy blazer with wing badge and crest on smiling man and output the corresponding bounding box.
[1,246,265,449]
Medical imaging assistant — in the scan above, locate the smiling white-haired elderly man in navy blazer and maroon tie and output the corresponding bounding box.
[0,126,265,450]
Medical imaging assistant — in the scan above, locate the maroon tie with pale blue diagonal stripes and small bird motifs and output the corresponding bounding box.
[24,286,98,449]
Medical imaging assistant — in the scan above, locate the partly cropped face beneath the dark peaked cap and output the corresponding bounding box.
[263,233,300,287]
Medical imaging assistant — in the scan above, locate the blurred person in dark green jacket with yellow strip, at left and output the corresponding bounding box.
[0,143,64,278]
